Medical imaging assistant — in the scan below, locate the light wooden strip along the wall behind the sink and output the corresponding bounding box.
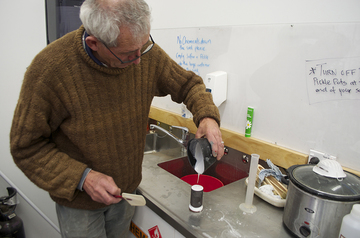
[149,106,360,176]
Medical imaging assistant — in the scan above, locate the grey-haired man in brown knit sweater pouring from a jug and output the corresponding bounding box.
[10,0,223,237]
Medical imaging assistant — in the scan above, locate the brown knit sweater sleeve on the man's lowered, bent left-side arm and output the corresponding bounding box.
[10,54,87,201]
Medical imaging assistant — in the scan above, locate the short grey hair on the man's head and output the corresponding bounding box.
[80,0,151,47]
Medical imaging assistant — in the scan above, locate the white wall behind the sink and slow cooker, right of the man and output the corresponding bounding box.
[149,0,360,171]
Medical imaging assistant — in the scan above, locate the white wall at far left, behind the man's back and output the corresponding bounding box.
[0,0,60,238]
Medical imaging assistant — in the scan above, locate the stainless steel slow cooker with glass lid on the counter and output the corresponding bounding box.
[283,164,360,238]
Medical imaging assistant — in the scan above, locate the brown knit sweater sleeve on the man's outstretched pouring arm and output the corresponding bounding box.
[150,46,220,126]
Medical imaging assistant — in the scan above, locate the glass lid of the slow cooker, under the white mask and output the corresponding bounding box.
[290,165,360,200]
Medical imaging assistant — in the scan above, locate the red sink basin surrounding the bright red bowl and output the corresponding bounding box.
[158,148,250,192]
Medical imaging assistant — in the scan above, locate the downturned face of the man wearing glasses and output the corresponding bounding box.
[94,27,150,68]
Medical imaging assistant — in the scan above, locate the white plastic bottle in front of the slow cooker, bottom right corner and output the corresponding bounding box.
[339,204,360,238]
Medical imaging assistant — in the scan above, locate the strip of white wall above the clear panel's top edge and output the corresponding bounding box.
[147,0,360,29]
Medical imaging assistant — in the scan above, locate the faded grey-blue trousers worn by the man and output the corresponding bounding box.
[56,200,135,238]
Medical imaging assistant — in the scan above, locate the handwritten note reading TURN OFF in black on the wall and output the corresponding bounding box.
[306,57,360,104]
